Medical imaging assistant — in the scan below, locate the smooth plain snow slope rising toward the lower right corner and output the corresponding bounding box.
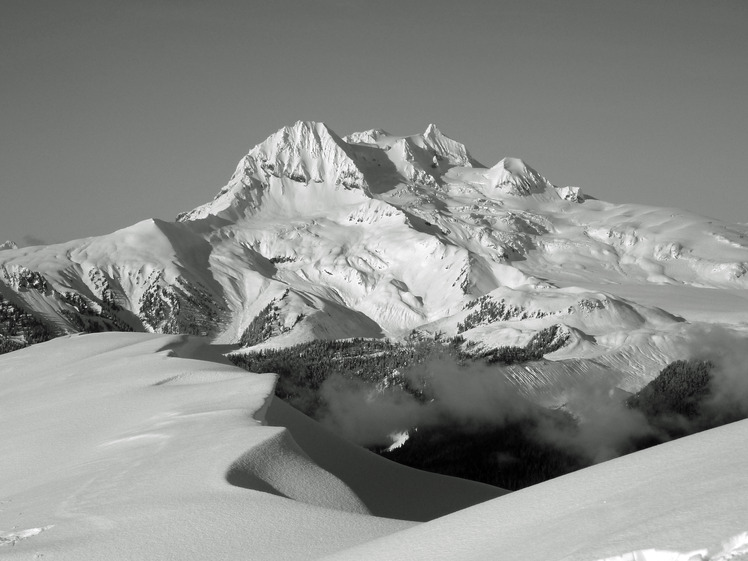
[326,421,748,561]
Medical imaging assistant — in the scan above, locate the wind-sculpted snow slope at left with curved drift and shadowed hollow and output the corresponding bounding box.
[0,333,502,559]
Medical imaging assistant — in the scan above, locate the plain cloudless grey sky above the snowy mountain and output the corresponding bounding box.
[0,0,748,245]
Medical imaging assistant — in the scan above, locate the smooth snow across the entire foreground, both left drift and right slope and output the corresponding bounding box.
[0,333,748,561]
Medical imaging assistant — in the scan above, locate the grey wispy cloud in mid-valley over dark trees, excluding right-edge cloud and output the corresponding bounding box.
[321,352,624,459]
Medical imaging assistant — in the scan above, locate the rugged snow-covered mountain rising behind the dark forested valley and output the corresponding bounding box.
[0,122,748,401]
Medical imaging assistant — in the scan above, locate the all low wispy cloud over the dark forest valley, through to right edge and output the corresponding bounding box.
[321,326,748,463]
